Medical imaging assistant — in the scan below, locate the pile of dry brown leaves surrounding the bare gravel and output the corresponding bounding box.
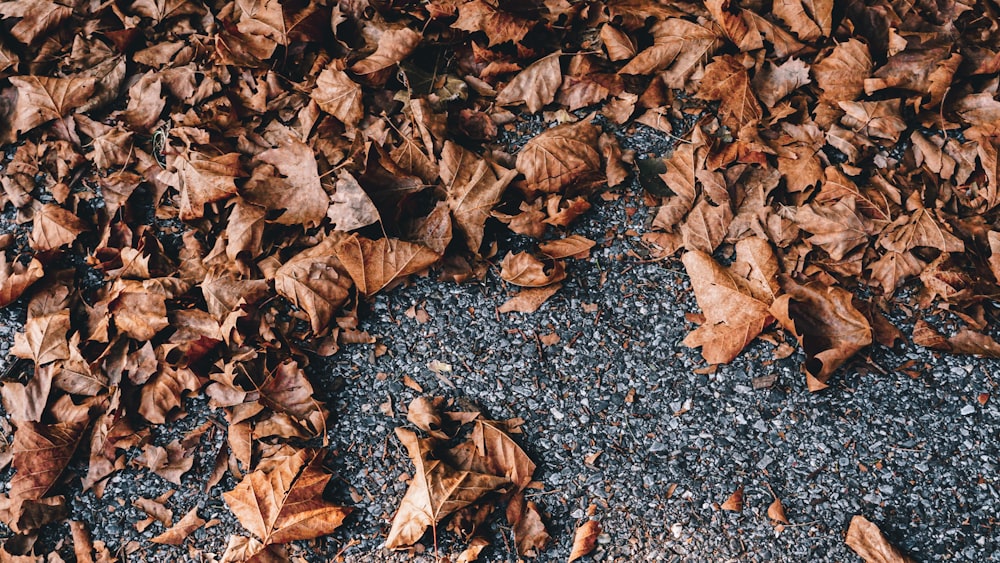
[0,0,1000,560]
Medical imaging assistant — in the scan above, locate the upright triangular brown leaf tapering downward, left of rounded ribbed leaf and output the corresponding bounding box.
[441,141,517,252]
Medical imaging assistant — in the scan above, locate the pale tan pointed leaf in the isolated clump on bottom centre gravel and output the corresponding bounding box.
[385,428,510,549]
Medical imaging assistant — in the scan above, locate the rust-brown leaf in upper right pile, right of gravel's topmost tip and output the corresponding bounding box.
[697,55,763,131]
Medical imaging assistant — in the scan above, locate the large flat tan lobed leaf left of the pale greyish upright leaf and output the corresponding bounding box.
[243,135,329,229]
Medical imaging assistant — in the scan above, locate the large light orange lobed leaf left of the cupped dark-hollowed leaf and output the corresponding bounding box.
[682,238,778,364]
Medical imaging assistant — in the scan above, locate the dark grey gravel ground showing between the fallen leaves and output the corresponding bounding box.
[0,124,1000,562]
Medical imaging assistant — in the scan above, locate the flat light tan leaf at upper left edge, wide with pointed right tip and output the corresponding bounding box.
[9,76,97,133]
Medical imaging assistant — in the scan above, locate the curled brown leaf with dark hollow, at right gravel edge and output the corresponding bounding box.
[771,278,873,391]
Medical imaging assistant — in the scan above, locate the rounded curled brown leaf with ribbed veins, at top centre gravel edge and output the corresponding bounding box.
[517,121,601,193]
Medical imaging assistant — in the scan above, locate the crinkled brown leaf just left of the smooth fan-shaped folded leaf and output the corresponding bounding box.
[274,236,352,334]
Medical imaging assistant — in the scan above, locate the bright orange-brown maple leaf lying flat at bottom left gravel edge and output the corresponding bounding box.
[222,449,350,547]
